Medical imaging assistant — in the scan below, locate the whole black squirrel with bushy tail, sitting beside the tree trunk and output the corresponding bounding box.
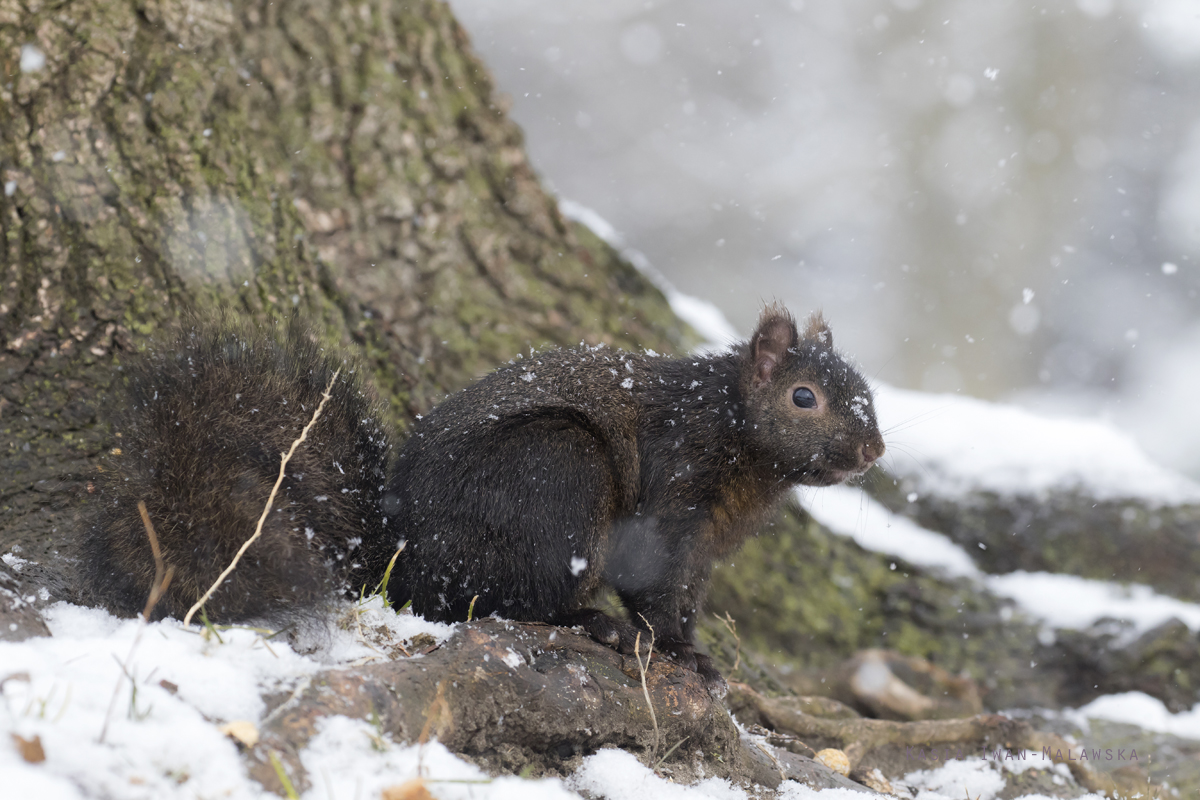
[83,306,884,691]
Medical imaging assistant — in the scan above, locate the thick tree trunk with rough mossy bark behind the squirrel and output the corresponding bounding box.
[0,0,686,561]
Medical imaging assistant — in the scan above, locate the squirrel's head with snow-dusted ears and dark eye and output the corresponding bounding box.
[740,305,884,486]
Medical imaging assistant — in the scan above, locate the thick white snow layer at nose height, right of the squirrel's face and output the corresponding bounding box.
[875,386,1200,504]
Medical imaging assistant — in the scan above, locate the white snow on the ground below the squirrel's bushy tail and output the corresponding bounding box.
[0,600,458,800]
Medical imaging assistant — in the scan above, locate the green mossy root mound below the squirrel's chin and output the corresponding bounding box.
[702,509,1057,709]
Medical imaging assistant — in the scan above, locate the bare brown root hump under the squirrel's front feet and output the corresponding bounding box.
[246,619,851,792]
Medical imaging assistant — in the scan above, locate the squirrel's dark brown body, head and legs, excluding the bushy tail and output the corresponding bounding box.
[384,308,883,681]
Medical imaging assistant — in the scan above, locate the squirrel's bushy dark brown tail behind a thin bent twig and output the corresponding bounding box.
[82,319,392,621]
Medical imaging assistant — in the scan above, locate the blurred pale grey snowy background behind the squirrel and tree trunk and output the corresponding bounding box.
[451,0,1200,477]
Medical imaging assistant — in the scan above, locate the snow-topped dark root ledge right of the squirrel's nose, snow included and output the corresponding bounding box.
[865,387,1200,602]
